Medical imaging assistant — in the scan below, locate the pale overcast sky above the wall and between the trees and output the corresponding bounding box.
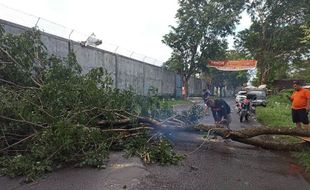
[0,0,250,65]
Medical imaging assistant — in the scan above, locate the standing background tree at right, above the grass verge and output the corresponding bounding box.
[236,0,310,84]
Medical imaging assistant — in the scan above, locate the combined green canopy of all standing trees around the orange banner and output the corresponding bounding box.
[162,0,310,88]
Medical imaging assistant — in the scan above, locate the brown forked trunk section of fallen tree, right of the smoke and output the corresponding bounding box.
[194,124,310,151]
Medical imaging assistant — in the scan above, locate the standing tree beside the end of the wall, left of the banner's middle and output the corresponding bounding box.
[163,0,244,95]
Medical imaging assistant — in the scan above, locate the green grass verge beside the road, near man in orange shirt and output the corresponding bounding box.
[256,91,310,172]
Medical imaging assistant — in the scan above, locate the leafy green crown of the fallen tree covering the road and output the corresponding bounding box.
[0,26,182,181]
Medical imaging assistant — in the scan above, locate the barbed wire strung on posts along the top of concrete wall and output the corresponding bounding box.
[0,3,163,66]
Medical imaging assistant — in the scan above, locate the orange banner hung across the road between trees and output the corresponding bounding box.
[208,60,257,71]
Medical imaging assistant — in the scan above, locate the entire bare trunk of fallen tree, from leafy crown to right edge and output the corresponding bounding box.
[98,114,310,151]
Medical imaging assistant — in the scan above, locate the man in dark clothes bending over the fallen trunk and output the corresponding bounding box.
[207,99,231,129]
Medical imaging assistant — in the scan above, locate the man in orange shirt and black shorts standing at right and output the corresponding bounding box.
[289,81,310,129]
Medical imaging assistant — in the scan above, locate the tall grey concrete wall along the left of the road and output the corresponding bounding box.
[0,19,207,96]
